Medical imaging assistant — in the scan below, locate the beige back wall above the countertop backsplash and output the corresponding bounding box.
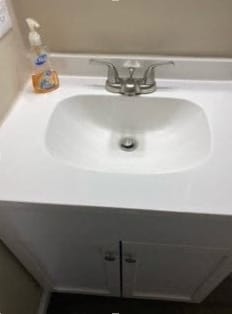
[13,0,232,57]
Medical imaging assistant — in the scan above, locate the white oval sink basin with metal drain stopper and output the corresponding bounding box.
[46,95,210,174]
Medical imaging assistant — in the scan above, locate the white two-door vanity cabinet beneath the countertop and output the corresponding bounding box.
[0,203,232,302]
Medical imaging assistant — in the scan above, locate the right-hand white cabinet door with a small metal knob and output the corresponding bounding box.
[122,242,232,302]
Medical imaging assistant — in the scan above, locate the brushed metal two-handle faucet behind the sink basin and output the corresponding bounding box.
[90,59,174,96]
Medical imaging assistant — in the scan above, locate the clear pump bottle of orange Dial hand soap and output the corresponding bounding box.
[26,18,59,93]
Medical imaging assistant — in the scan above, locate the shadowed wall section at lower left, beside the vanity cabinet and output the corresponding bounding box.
[0,242,41,314]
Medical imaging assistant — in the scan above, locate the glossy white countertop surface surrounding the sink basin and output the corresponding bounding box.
[0,76,232,215]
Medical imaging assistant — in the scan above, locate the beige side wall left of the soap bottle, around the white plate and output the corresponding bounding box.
[0,1,28,123]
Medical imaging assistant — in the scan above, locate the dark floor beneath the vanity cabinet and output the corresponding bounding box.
[47,277,232,314]
